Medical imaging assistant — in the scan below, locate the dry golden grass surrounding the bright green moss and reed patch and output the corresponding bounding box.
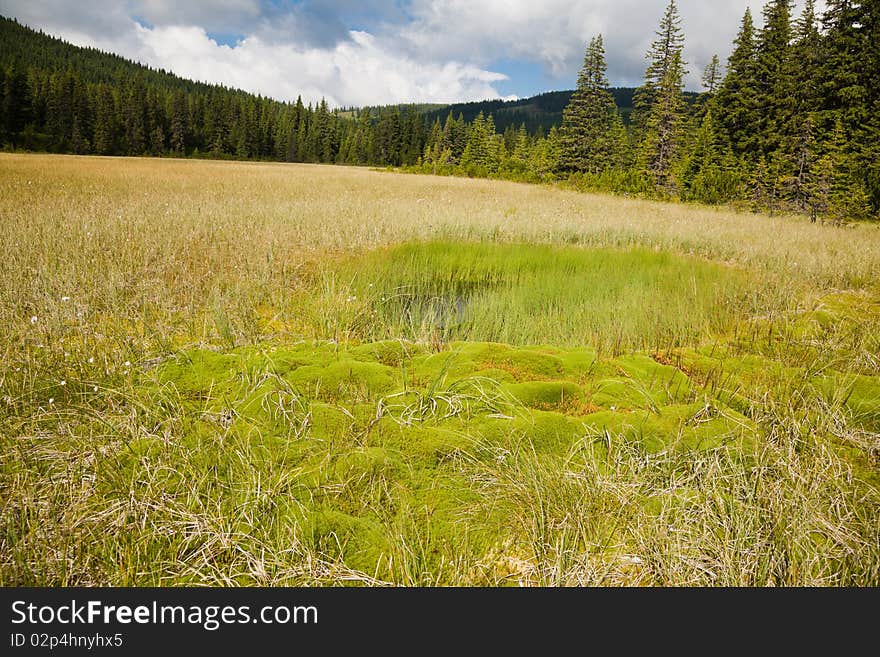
[0,154,880,585]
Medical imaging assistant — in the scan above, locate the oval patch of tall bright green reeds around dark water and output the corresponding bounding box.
[317,241,757,353]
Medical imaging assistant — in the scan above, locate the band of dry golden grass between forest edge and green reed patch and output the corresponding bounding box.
[0,154,880,322]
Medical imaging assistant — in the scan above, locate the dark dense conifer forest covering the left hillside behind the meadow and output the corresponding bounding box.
[0,18,425,166]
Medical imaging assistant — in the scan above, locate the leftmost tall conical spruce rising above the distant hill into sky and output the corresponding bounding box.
[559,35,620,173]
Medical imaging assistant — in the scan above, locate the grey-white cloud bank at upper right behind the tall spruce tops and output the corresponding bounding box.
[391,0,821,87]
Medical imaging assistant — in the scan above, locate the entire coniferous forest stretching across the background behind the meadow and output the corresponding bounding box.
[0,0,880,223]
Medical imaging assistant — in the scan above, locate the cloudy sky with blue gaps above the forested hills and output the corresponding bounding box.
[0,0,821,107]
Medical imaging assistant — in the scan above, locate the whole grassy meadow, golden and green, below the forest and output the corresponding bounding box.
[0,154,880,586]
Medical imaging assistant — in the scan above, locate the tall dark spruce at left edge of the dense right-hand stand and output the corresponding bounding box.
[715,9,759,155]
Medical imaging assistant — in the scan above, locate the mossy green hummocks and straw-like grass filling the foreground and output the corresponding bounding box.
[3,320,880,585]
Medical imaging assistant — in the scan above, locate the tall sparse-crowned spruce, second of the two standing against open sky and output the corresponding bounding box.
[631,0,687,134]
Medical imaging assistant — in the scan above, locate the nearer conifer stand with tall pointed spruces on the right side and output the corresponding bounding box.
[419,0,880,222]
